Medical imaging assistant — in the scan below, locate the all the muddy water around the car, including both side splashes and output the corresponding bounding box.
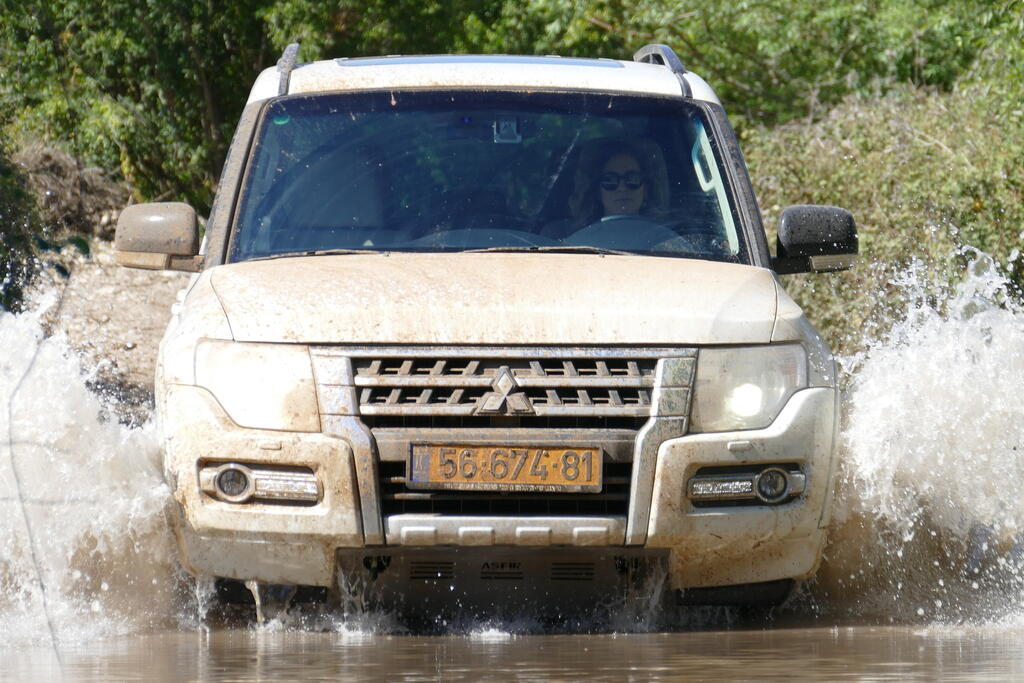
[0,254,1024,681]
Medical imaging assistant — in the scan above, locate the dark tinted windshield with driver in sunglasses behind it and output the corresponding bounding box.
[230,90,746,262]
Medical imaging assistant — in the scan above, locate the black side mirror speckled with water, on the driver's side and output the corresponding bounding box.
[772,204,857,274]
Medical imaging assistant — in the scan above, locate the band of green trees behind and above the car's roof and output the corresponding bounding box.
[6,0,1019,211]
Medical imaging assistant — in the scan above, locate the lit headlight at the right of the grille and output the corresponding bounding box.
[690,344,807,432]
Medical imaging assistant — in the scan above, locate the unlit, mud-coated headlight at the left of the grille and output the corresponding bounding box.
[196,339,319,432]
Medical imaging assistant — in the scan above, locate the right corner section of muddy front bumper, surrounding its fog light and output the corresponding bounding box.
[646,388,837,588]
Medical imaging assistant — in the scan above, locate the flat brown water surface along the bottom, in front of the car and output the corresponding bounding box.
[6,627,1024,682]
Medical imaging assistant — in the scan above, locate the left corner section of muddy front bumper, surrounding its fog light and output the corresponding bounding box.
[159,385,364,586]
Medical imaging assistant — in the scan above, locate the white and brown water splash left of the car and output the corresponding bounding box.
[0,292,188,646]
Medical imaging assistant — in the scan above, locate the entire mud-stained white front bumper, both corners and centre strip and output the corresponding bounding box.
[160,385,836,588]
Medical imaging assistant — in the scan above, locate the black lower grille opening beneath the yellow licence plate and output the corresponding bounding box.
[380,461,633,517]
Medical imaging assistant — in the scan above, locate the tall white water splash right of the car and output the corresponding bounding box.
[814,254,1024,623]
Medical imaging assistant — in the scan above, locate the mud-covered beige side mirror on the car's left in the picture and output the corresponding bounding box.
[114,202,200,272]
